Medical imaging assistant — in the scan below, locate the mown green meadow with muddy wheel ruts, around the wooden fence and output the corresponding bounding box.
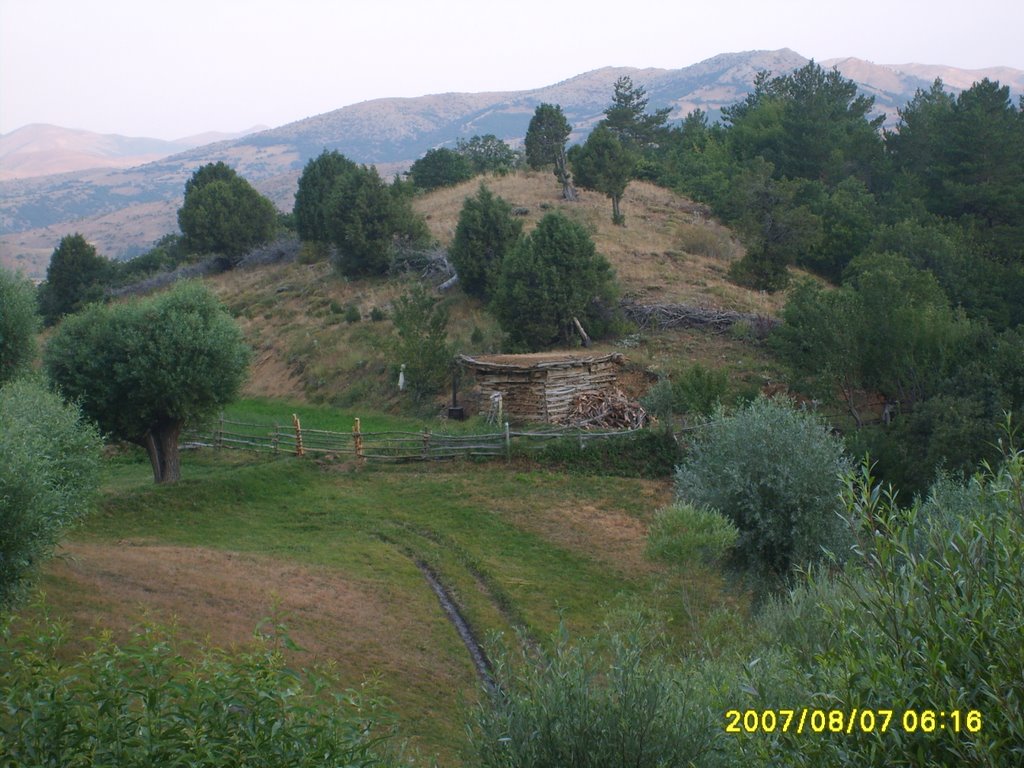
[28,421,732,765]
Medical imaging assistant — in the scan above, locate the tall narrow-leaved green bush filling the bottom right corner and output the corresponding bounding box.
[738,446,1024,766]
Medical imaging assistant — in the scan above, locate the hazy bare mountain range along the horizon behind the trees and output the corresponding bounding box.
[0,48,1024,278]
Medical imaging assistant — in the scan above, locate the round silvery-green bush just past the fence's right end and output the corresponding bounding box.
[676,397,850,586]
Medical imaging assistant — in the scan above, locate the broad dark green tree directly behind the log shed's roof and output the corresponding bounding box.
[493,213,614,349]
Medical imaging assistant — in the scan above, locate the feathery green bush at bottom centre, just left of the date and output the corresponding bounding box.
[467,627,721,768]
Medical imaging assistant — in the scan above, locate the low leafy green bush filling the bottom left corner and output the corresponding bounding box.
[0,624,399,768]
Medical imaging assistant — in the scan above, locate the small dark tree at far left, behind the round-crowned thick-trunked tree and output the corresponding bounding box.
[39,232,114,325]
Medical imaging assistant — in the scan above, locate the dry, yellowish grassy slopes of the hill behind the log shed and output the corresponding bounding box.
[207,173,782,410]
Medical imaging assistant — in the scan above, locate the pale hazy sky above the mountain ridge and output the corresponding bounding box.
[0,0,1024,139]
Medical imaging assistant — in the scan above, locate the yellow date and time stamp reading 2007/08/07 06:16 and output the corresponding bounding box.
[725,707,982,733]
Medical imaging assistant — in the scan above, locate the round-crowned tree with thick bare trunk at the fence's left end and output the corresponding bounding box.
[44,284,249,482]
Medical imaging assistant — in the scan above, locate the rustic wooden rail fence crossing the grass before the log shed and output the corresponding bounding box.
[181,415,638,462]
